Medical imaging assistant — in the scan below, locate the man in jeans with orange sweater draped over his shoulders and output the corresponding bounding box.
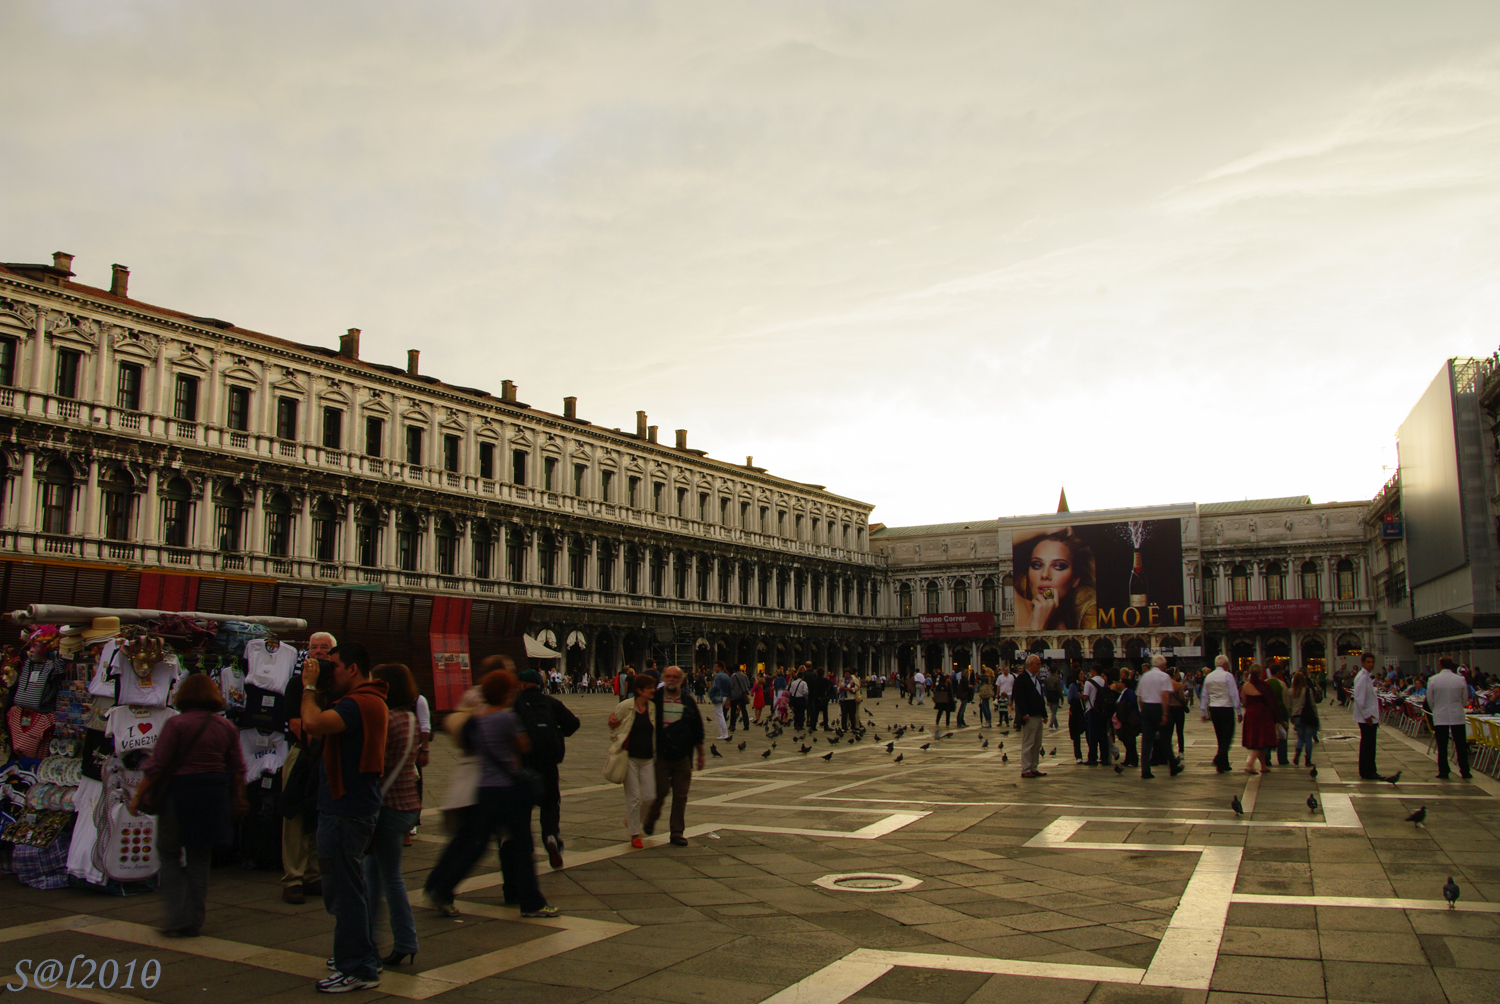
[302,642,390,993]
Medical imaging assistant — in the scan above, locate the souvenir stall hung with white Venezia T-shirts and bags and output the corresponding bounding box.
[0,605,308,894]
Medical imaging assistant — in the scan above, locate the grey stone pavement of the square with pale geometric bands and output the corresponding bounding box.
[0,695,1500,1004]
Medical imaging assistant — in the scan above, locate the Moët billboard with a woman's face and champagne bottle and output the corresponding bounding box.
[1011,519,1187,635]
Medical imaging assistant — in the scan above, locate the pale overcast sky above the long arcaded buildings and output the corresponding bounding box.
[0,0,1500,525]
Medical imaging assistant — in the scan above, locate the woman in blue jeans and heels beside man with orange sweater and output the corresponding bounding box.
[365,663,422,966]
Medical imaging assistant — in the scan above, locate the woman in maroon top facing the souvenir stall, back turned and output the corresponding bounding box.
[131,672,248,938]
